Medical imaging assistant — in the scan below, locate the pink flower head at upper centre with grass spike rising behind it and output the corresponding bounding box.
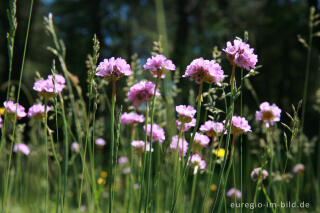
[143,54,176,78]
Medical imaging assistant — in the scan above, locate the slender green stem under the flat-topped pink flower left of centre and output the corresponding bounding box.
[109,79,116,213]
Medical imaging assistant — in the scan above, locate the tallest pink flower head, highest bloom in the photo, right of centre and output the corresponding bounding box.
[223,39,258,71]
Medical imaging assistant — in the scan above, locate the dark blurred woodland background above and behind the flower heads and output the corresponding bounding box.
[0,0,320,136]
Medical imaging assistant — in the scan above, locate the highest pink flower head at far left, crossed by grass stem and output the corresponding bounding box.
[33,74,66,98]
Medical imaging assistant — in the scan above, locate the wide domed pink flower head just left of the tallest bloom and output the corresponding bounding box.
[182,58,225,86]
